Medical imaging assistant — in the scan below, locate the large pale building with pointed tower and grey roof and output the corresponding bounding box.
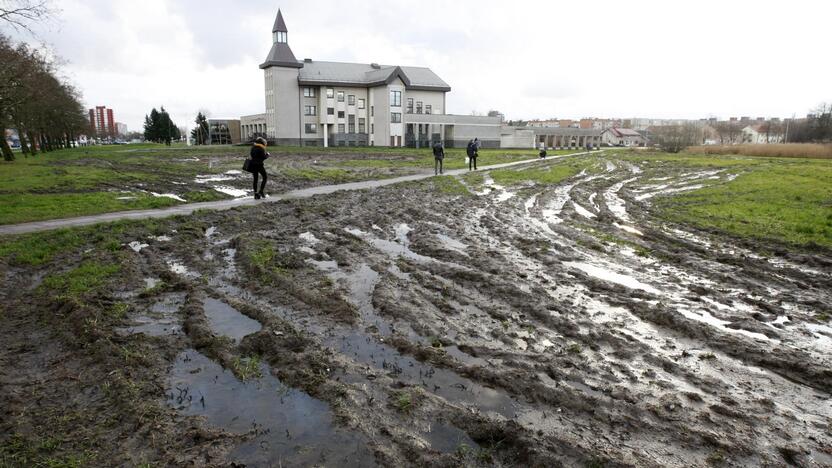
[260,11,501,147]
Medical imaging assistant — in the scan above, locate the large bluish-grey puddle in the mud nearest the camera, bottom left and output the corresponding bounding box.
[168,350,376,466]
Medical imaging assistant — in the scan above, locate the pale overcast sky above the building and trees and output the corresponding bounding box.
[9,0,832,130]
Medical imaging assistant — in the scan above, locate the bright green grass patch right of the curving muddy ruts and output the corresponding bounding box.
[656,157,832,247]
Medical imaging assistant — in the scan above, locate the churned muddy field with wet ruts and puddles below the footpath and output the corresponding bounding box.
[0,153,832,467]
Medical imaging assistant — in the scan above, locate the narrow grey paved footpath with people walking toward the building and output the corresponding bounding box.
[0,151,597,235]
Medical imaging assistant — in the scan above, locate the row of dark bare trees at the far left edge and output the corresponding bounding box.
[0,34,89,161]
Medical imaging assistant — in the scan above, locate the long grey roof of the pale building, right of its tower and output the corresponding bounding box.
[298,61,451,91]
